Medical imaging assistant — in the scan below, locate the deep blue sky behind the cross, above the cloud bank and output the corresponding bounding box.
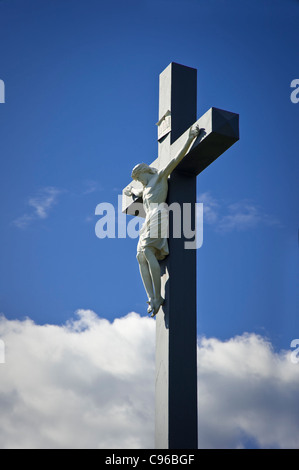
[0,0,299,448]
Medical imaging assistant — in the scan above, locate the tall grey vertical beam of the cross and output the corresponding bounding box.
[155,63,197,449]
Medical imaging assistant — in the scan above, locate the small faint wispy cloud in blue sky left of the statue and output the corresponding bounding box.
[13,186,62,228]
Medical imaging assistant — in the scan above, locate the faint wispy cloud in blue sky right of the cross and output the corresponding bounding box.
[198,192,279,232]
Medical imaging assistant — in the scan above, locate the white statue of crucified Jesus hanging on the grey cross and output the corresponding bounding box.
[124,126,202,317]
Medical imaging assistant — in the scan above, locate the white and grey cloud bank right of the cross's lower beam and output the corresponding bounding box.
[198,334,299,448]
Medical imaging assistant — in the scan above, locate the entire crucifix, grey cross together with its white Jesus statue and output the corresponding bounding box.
[122,62,239,449]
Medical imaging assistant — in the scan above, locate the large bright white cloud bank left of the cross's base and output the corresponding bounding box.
[0,310,154,448]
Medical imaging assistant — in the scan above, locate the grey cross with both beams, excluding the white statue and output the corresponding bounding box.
[123,62,239,449]
